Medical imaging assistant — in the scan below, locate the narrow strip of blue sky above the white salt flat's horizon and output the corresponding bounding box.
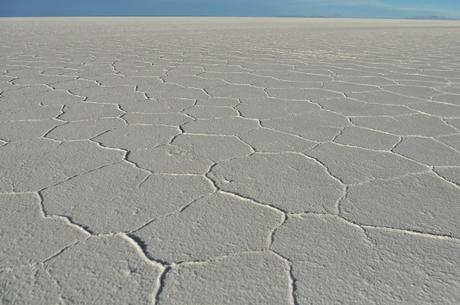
[0,0,460,18]
